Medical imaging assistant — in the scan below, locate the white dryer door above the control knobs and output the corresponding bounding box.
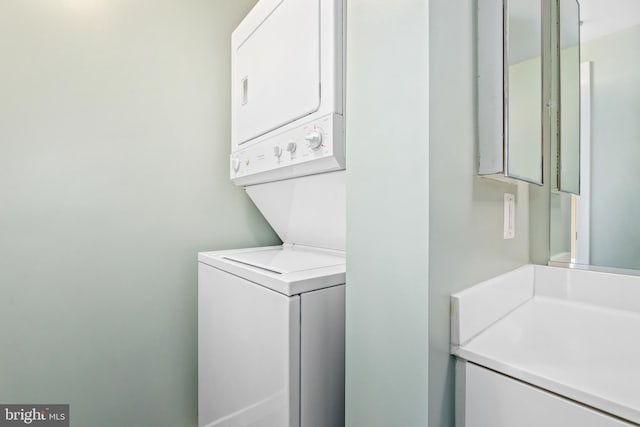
[232,0,320,145]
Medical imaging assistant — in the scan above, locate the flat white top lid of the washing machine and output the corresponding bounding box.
[223,247,345,274]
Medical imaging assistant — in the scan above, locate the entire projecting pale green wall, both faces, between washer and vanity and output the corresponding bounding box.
[346,0,528,427]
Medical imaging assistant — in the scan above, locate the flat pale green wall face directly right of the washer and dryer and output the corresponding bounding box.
[346,0,429,427]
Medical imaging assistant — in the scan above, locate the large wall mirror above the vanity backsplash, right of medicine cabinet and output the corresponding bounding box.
[550,0,640,270]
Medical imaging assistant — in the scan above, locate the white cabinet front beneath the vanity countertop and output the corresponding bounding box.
[456,361,632,427]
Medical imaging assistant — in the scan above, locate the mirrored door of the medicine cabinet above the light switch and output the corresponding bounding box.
[505,0,543,184]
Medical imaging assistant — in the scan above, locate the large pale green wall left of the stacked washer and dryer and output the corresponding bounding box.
[0,0,277,427]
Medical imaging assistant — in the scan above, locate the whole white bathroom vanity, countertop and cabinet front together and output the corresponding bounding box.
[451,265,640,427]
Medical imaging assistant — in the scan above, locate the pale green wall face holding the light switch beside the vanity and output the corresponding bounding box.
[428,0,532,427]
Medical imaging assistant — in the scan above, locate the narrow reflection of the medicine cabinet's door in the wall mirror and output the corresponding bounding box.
[552,0,580,194]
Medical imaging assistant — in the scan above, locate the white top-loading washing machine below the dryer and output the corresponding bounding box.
[198,244,345,427]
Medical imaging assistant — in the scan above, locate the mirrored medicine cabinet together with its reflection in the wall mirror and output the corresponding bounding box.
[477,0,580,189]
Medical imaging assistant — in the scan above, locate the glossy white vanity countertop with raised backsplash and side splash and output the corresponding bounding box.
[452,266,640,424]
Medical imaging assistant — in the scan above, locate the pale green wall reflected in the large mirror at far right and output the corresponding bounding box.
[581,26,640,269]
